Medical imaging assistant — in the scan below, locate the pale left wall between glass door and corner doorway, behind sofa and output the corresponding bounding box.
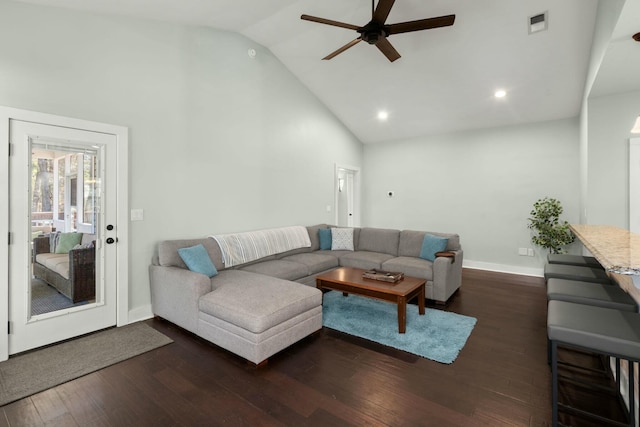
[0,0,362,318]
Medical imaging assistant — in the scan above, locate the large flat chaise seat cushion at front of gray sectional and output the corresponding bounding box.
[198,270,322,334]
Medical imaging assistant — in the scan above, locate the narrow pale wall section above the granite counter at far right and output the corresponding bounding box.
[585,91,640,229]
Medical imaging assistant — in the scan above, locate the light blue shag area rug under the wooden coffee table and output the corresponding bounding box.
[322,291,477,363]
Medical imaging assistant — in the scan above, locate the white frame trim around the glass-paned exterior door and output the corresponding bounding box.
[0,106,129,361]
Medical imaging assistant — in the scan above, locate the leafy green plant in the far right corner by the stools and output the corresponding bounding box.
[527,197,576,254]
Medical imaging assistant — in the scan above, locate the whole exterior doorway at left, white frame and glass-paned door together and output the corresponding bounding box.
[0,107,128,361]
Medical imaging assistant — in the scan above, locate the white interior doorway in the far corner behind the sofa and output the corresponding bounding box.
[335,165,360,227]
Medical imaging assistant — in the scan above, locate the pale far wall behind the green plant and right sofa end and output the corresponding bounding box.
[363,118,580,275]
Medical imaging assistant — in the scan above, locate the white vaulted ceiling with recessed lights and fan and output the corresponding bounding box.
[11,0,640,143]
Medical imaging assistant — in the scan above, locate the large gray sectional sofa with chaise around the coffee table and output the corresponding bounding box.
[149,224,463,364]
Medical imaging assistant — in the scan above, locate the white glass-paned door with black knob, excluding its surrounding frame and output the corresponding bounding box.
[5,119,118,354]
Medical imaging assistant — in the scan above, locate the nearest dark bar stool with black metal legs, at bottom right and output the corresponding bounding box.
[547,300,640,427]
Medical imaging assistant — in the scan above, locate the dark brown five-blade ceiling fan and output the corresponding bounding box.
[300,0,456,62]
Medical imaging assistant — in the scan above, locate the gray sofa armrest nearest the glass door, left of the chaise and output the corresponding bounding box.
[149,265,211,333]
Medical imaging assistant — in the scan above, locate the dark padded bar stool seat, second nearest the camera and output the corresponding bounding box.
[547,278,638,312]
